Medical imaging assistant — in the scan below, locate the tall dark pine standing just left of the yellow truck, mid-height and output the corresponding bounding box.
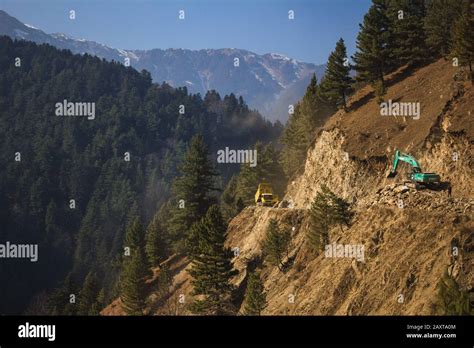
[169,135,217,251]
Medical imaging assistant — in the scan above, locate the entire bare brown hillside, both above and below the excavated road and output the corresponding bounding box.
[103,60,474,315]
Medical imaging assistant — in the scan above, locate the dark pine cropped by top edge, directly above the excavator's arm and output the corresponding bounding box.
[388,0,427,66]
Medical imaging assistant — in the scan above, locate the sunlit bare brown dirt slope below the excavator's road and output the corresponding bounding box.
[228,187,474,315]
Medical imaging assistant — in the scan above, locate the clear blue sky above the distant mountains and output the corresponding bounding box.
[0,0,370,64]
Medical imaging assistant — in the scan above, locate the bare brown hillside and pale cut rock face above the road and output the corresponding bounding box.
[285,59,474,208]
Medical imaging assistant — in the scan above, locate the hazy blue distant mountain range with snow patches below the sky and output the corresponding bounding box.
[0,10,325,122]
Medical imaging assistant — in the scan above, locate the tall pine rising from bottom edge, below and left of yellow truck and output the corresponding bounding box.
[189,205,236,315]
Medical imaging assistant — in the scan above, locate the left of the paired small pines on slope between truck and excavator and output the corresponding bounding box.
[307,185,333,252]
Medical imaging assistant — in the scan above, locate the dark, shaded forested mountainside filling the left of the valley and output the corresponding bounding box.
[0,37,281,314]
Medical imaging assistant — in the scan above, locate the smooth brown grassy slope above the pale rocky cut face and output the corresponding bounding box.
[325,59,474,159]
